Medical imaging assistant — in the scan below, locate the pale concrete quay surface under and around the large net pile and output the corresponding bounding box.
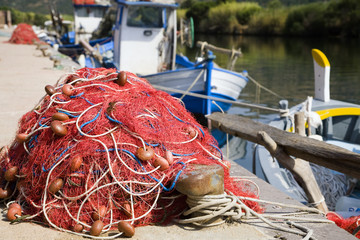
[0,31,356,240]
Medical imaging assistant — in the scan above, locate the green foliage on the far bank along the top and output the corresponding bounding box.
[0,0,360,37]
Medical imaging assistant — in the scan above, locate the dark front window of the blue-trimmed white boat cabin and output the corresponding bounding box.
[126,6,163,28]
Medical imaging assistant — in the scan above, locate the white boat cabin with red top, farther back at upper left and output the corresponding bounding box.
[73,0,111,43]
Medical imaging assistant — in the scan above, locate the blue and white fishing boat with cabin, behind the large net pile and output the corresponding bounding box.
[79,0,248,115]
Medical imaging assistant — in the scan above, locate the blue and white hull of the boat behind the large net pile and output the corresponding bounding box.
[143,67,248,114]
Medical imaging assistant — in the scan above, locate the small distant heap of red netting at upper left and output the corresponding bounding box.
[9,23,40,44]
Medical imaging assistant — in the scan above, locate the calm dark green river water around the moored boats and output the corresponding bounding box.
[181,35,360,178]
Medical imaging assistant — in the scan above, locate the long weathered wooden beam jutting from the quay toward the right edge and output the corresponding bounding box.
[207,112,360,178]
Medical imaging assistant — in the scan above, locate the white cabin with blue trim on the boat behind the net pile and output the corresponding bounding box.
[114,0,177,75]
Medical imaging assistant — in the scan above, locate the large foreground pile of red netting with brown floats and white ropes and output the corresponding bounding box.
[0,68,260,238]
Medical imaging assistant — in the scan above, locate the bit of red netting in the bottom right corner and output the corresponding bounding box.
[326,212,360,239]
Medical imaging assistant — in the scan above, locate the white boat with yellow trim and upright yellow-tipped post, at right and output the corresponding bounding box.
[257,49,360,213]
